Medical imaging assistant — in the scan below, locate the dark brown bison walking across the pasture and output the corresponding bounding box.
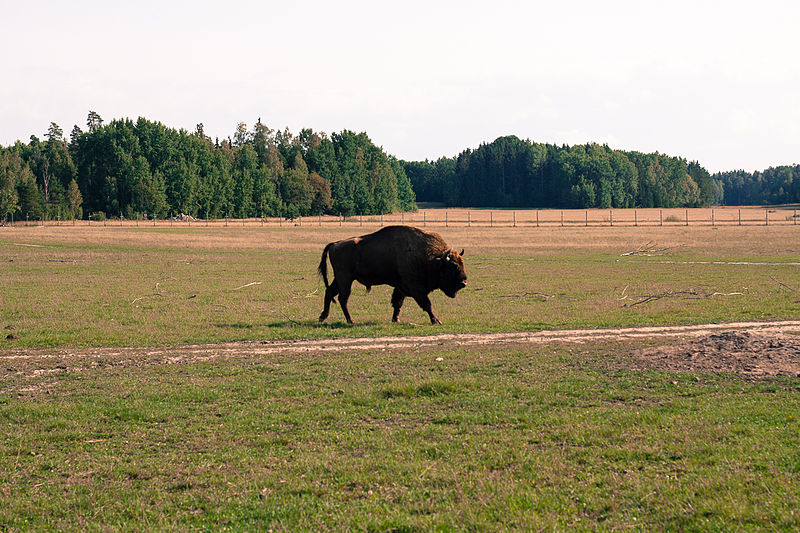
[319,226,467,324]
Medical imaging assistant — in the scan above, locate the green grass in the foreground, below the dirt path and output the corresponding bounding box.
[0,344,800,531]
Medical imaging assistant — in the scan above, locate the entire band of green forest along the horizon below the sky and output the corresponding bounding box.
[0,111,800,223]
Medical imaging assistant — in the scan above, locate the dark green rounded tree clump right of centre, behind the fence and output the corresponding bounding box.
[405,136,722,208]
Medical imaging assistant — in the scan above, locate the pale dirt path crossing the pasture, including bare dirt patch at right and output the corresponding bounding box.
[6,320,800,377]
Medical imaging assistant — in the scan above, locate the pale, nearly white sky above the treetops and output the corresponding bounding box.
[0,0,800,172]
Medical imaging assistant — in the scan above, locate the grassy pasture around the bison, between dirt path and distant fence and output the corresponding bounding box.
[0,222,800,348]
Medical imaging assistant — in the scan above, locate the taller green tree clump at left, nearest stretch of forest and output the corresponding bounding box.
[0,112,416,221]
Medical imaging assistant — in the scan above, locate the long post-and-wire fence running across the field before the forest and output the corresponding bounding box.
[7,207,798,228]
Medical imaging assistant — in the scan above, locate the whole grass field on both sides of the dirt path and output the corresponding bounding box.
[0,219,800,531]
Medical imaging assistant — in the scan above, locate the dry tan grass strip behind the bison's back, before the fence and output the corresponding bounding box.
[0,216,800,258]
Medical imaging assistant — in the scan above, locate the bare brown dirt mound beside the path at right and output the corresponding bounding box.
[634,331,800,377]
